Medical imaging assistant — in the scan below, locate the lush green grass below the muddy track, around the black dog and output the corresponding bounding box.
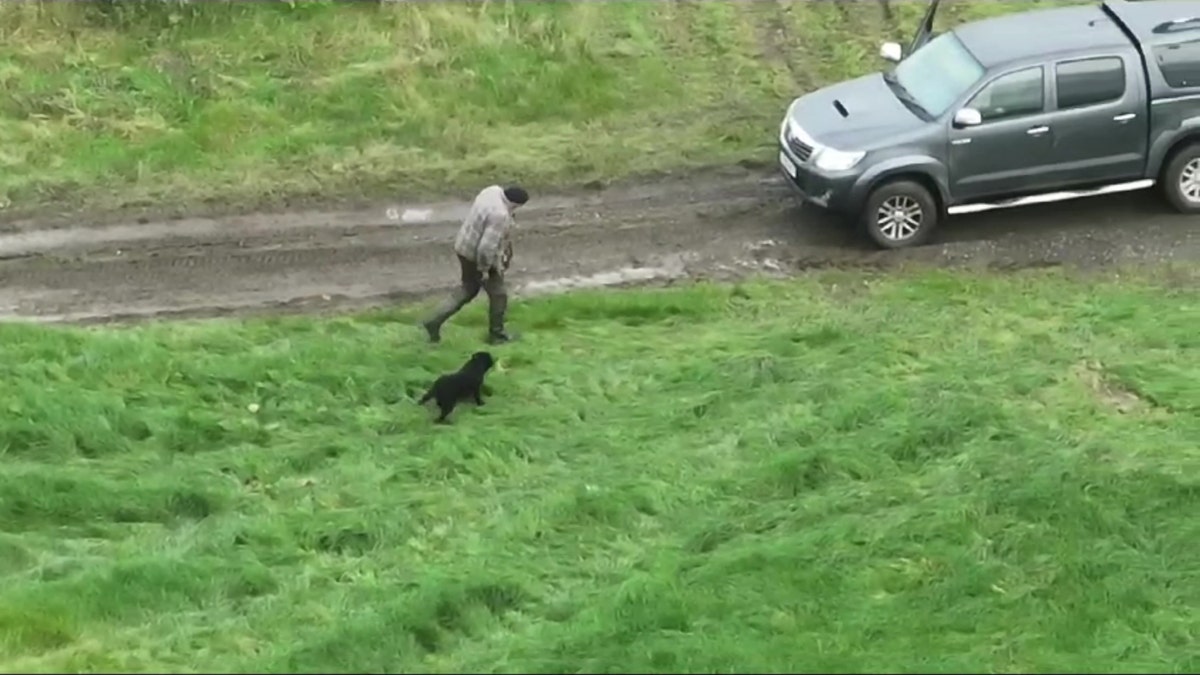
[0,266,1200,673]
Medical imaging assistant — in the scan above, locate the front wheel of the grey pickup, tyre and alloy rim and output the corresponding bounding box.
[859,180,941,249]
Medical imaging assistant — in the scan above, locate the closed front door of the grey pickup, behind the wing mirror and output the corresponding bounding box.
[948,66,1054,202]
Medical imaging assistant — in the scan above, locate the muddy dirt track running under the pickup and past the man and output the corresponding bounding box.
[0,172,1200,321]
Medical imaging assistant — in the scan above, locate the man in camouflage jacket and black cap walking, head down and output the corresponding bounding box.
[421,185,529,345]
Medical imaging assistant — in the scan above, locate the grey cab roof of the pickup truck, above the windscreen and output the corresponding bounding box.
[954,0,1128,68]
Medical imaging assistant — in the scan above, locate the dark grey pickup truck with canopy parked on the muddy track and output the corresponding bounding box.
[779,0,1200,249]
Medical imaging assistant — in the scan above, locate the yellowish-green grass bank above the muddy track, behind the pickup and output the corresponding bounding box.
[0,0,1070,214]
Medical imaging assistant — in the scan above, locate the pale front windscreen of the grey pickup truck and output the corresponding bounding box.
[893,32,984,118]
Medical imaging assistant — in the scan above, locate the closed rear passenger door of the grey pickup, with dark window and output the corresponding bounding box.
[1045,54,1150,187]
